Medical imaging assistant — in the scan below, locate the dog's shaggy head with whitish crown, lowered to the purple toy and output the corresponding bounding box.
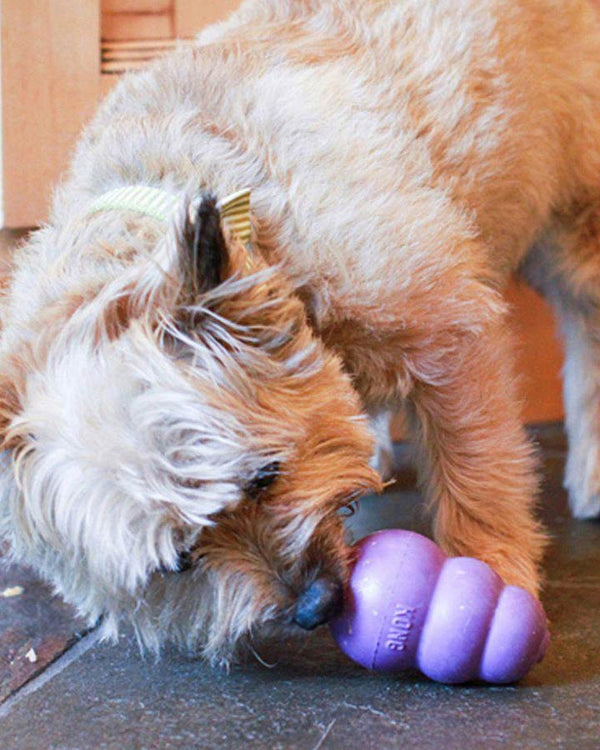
[2,196,379,661]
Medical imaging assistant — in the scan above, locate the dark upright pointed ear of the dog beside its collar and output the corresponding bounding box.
[184,193,230,294]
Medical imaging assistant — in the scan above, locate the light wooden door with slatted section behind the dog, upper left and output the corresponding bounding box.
[1,0,240,227]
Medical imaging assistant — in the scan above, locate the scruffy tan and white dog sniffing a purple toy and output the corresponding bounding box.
[0,0,600,662]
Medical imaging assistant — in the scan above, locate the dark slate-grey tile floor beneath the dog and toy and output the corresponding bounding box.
[0,424,600,750]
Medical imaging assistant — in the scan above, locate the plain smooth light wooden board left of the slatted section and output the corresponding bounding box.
[2,0,100,227]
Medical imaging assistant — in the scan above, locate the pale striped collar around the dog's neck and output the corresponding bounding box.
[85,185,252,245]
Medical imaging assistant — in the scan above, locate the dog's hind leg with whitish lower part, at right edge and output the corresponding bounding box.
[523,213,600,518]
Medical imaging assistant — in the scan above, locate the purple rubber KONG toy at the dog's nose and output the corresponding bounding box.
[331,530,550,683]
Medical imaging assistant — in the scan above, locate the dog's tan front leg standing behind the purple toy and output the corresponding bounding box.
[408,320,545,594]
